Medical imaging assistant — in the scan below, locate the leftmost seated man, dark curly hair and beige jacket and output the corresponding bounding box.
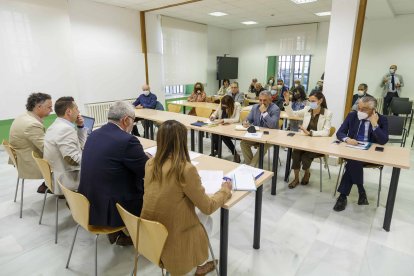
[9,93,53,193]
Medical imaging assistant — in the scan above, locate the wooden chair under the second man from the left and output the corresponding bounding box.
[32,151,59,243]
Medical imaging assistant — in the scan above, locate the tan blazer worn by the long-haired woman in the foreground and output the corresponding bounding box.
[141,158,231,275]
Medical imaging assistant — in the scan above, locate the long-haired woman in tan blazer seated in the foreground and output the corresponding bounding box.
[141,120,232,275]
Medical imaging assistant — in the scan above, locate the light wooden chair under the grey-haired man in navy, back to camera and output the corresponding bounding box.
[58,180,125,275]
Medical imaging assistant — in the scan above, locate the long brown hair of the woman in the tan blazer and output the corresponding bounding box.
[151,120,191,182]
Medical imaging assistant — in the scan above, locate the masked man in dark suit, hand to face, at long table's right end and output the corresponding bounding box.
[334,97,388,212]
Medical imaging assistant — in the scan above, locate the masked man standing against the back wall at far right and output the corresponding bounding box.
[380,65,404,115]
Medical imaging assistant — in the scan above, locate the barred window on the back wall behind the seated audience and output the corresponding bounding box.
[276,55,311,92]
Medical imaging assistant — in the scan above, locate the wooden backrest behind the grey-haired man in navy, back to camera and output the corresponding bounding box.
[57,180,89,230]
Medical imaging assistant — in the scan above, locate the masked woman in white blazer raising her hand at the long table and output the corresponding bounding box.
[284,92,332,189]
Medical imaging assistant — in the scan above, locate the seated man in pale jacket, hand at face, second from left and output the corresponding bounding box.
[44,97,87,195]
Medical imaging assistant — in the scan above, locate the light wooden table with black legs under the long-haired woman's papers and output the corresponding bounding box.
[139,138,273,276]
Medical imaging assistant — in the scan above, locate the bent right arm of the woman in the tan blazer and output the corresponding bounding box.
[182,166,231,215]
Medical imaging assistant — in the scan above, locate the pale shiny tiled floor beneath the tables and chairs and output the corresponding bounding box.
[0,128,414,276]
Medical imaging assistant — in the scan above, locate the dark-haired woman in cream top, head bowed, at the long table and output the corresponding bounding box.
[210,95,241,163]
